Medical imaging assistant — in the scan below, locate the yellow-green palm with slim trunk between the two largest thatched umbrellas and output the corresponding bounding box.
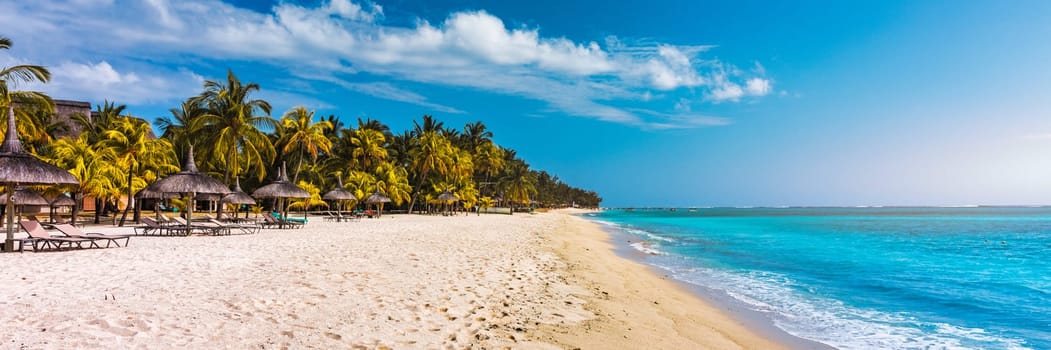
[100,117,179,226]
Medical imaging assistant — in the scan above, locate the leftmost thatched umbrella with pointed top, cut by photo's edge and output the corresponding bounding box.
[0,105,79,251]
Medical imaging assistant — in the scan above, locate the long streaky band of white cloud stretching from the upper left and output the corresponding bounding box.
[0,0,772,126]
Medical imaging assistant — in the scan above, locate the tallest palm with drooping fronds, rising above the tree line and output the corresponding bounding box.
[190,70,276,184]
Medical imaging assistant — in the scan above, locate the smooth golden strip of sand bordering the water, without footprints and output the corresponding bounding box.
[531,211,790,349]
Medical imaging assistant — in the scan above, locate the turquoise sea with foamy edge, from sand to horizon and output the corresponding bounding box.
[588,207,1051,349]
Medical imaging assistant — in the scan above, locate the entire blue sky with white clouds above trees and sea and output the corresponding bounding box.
[0,0,1051,206]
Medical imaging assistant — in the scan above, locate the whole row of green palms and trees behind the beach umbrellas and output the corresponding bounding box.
[0,38,601,220]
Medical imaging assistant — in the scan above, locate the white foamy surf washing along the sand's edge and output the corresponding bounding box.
[650,256,1028,349]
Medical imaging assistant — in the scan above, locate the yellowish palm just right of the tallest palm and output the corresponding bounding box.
[279,106,332,182]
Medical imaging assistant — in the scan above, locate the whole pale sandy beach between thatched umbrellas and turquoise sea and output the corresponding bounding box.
[0,213,779,349]
